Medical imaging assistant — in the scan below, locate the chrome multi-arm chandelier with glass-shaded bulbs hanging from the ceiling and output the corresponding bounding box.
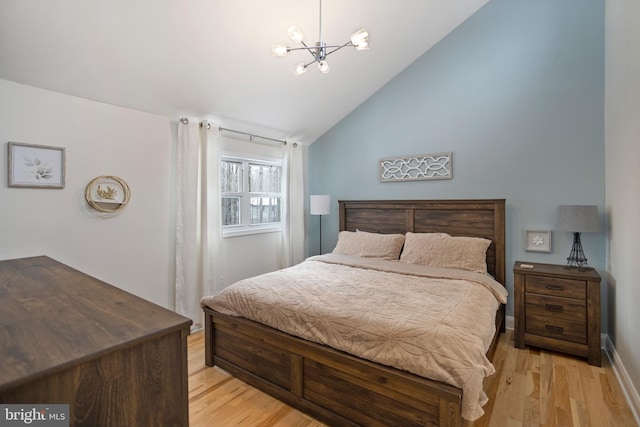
[271,0,369,76]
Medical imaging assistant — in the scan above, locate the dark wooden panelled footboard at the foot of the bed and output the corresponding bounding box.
[204,308,462,427]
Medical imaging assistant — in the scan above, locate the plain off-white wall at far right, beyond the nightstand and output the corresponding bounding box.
[605,0,640,421]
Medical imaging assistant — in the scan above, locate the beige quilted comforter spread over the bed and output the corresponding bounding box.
[201,254,507,420]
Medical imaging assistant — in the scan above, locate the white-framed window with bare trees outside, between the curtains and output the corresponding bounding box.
[220,157,282,235]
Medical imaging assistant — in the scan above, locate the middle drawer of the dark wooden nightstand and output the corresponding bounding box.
[525,294,587,325]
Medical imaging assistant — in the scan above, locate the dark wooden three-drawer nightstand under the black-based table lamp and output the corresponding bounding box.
[513,261,601,366]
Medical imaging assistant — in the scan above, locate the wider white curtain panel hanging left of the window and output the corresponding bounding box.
[175,119,223,330]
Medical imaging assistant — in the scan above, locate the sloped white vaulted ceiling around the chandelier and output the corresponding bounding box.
[0,0,488,144]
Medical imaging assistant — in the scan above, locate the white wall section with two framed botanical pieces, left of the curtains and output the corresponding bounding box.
[0,80,174,307]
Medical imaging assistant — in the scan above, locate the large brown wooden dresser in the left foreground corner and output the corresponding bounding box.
[0,257,191,427]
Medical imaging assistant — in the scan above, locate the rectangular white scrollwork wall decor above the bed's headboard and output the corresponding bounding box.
[380,153,453,182]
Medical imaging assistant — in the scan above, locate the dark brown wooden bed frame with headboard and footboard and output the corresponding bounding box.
[204,199,506,426]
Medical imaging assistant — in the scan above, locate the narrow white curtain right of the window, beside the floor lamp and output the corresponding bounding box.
[281,143,305,268]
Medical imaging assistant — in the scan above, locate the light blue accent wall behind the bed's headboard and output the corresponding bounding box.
[309,0,607,320]
